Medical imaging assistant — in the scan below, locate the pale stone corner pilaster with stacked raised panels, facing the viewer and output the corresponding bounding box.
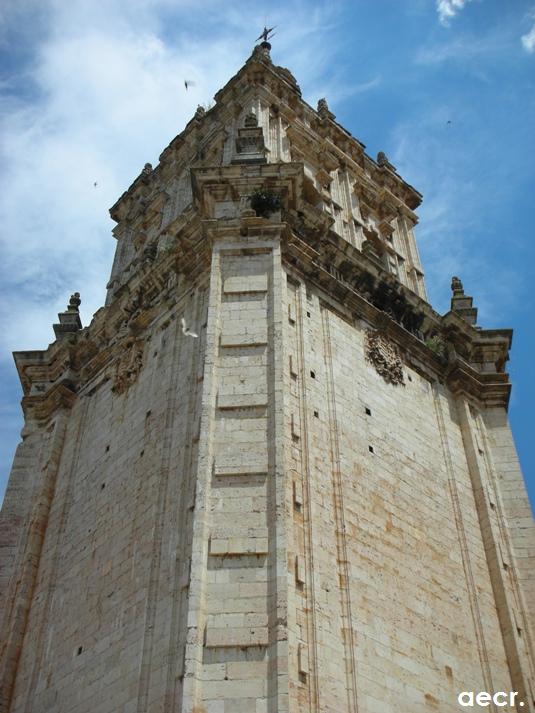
[182,219,288,713]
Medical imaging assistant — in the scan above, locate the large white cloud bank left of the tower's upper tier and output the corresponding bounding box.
[0,0,340,360]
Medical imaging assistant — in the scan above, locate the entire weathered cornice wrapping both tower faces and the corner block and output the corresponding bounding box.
[14,154,511,420]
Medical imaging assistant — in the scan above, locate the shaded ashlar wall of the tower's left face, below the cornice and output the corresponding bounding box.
[1,285,207,713]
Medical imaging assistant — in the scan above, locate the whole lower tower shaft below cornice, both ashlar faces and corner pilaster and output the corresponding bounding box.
[4,239,534,713]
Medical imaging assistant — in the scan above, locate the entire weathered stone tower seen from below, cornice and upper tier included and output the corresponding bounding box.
[0,42,535,713]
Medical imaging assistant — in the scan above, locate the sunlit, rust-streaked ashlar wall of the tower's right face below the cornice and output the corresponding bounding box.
[285,277,533,713]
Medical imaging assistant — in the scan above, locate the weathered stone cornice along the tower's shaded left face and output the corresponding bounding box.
[13,214,211,423]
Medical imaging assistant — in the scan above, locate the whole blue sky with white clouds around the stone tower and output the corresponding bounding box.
[0,0,535,503]
